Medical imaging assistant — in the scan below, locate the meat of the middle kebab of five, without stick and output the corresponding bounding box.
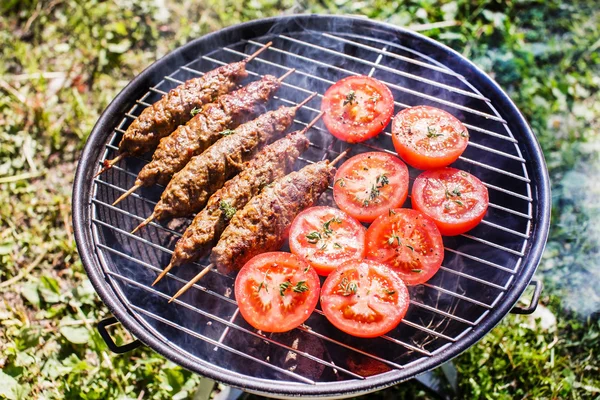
[154,107,296,219]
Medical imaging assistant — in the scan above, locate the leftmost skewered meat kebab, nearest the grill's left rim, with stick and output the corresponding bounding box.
[98,42,271,175]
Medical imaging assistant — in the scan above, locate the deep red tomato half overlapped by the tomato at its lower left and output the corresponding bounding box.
[366,208,444,285]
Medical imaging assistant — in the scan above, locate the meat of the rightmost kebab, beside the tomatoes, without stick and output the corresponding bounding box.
[210,161,335,273]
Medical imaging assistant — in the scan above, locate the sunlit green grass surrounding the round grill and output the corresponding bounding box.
[0,0,600,399]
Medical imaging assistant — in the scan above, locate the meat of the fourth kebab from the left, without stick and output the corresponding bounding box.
[171,131,309,266]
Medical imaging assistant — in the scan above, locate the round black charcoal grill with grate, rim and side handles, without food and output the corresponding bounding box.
[73,15,550,397]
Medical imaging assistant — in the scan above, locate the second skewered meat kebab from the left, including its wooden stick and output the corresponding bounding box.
[113,73,288,205]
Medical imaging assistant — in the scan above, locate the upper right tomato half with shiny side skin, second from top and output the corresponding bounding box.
[392,106,469,169]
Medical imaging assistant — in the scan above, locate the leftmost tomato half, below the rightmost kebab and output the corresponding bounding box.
[235,252,320,332]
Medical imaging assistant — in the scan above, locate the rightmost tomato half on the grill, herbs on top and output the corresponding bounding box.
[411,168,489,236]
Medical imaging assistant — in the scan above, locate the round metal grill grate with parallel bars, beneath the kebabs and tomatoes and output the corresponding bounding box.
[84,18,535,394]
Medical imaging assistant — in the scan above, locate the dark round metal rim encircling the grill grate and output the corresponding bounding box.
[72,14,551,397]
